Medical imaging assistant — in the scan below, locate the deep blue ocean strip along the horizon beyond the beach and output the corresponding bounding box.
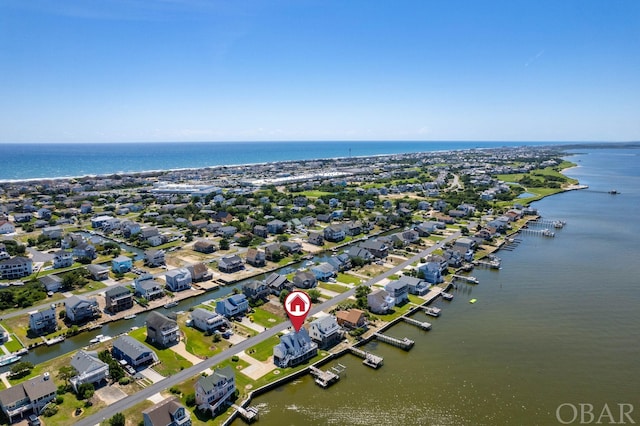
[0,141,550,181]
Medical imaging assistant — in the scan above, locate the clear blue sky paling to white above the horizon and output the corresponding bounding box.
[0,0,640,142]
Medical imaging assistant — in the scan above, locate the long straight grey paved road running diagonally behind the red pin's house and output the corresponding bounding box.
[76,232,460,426]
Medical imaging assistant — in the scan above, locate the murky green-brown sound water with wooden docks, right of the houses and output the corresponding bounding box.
[240,149,640,426]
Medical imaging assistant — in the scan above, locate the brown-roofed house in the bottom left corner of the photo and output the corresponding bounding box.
[0,372,58,424]
